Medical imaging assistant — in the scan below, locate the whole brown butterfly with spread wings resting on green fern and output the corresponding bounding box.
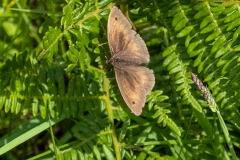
[107,6,155,116]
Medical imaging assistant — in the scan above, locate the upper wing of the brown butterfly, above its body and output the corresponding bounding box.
[108,6,149,64]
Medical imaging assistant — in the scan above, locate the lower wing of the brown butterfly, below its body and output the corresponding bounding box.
[114,66,155,116]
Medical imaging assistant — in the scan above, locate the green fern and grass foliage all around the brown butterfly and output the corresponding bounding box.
[0,0,240,160]
